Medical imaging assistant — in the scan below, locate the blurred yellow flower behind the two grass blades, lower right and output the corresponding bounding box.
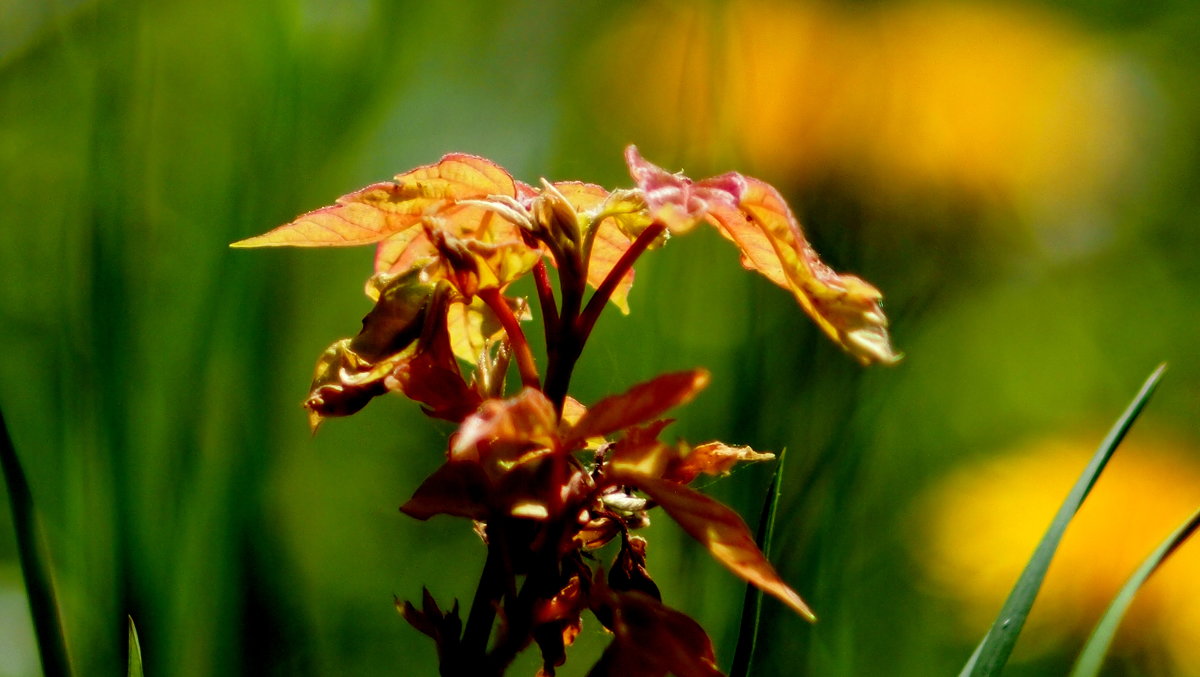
[913,439,1200,675]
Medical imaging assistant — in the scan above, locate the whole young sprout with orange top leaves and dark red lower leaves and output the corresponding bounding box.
[234,146,899,676]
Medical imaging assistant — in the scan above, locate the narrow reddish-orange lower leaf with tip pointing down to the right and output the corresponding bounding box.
[610,473,816,621]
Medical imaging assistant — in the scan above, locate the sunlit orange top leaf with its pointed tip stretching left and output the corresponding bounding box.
[233,154,516,247]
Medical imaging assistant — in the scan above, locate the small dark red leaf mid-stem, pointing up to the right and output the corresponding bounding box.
[565,369,709,448]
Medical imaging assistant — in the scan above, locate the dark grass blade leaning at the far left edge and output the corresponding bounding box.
[0,412,71,677]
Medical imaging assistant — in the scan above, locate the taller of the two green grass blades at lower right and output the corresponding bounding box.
[959,364,1166,677]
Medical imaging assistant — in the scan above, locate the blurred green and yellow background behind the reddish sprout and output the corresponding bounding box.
[0,0,1200,676]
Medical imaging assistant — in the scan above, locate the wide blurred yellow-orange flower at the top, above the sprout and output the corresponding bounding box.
[588,0,1140,226]
